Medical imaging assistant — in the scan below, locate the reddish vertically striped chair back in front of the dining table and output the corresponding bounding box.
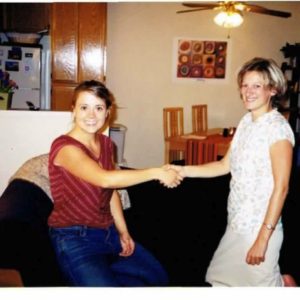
[185,139,218,165]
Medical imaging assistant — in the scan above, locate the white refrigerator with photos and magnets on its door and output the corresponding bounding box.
[0,44,50,110]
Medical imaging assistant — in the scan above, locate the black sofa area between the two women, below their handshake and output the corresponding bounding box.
[126,176,229,286]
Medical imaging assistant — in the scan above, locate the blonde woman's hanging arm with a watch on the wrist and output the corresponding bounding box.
[246,140,293,265]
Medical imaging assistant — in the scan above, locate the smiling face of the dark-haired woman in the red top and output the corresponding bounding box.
[73,91,108,134]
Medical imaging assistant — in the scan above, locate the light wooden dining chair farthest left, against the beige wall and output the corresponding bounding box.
[163,107,184,163]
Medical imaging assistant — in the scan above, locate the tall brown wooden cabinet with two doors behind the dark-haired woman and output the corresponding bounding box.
[51,3,107,110]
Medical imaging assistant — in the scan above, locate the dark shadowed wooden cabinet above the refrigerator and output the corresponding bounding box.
[0,3,51,32]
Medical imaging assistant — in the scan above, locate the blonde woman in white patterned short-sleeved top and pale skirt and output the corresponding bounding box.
[172,58,294,286]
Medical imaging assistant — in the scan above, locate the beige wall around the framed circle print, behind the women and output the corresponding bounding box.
[106,2,300,168]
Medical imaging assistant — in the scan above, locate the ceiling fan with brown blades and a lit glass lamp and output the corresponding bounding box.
[177,1,292,28]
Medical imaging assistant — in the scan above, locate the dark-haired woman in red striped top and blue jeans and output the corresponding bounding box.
[48,81,182,286]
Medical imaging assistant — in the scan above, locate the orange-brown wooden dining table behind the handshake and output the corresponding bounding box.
[165,128,233,164]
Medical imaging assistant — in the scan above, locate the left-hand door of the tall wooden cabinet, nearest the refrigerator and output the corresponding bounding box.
[51,3,78,83]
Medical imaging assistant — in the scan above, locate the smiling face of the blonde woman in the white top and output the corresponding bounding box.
[240,71,276,119]
